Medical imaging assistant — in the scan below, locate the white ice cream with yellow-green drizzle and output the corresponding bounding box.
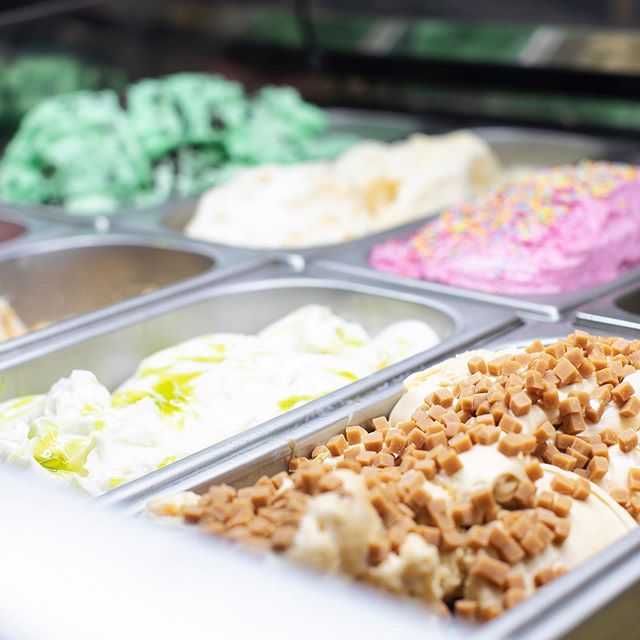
[0,305,438,494]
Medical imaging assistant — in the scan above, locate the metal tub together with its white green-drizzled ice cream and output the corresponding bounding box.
[0,264,508,493]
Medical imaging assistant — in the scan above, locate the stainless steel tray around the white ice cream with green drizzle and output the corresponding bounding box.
[0,263,519,492]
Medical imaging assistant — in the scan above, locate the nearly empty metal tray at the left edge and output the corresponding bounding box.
[0,229,265,353]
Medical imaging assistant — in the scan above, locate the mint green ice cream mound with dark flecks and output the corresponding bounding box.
[0,72,353,217]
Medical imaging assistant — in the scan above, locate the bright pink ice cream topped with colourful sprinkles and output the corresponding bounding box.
[369,162,640,294]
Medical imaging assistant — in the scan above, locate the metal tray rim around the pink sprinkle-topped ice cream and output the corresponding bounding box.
[318,220,640,320]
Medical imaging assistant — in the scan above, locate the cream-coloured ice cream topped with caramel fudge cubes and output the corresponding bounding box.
[155,331,640,622]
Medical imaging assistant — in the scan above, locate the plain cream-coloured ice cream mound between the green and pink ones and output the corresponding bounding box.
[186,131,501,248]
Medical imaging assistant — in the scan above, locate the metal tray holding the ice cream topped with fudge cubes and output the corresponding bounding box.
[107,322,640,640]
